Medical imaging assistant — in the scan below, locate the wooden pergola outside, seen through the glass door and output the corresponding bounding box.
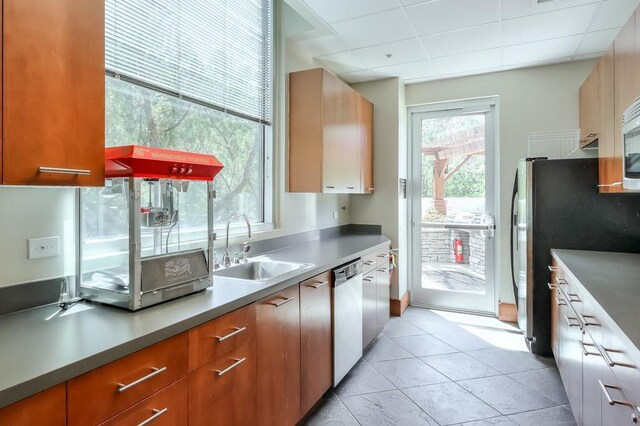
[422,126,485,215]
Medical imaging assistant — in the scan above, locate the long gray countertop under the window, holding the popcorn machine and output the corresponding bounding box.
[0,235,389,407]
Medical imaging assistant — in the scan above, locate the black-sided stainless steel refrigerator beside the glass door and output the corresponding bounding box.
[511,158,640,356]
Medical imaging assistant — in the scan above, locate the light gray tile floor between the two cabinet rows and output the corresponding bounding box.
[303,307,575,426]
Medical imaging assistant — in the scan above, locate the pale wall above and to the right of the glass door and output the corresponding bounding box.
[406,60,595,303]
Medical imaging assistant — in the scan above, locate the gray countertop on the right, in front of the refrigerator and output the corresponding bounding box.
[551,249,640,348]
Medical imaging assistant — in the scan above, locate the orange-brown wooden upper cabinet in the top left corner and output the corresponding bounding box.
[0,0,105,186]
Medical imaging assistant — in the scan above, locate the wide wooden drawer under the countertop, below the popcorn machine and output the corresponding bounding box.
[67,333,187,426]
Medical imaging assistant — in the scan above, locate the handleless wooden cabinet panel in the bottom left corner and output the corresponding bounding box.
[0,383,67,426]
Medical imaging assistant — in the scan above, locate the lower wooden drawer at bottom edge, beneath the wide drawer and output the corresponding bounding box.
[100,377,187,426]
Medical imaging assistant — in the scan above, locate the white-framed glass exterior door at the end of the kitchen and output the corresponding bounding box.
[410,102,496,313]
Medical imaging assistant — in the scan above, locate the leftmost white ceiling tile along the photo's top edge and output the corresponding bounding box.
[304,0,401,24]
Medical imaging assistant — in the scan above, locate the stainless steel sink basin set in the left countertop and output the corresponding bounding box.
[213,259,313,284]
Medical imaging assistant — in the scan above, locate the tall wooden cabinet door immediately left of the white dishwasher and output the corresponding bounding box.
[300,271,333,415]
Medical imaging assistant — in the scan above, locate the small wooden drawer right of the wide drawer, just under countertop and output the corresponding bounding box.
[189,305,256,371]
